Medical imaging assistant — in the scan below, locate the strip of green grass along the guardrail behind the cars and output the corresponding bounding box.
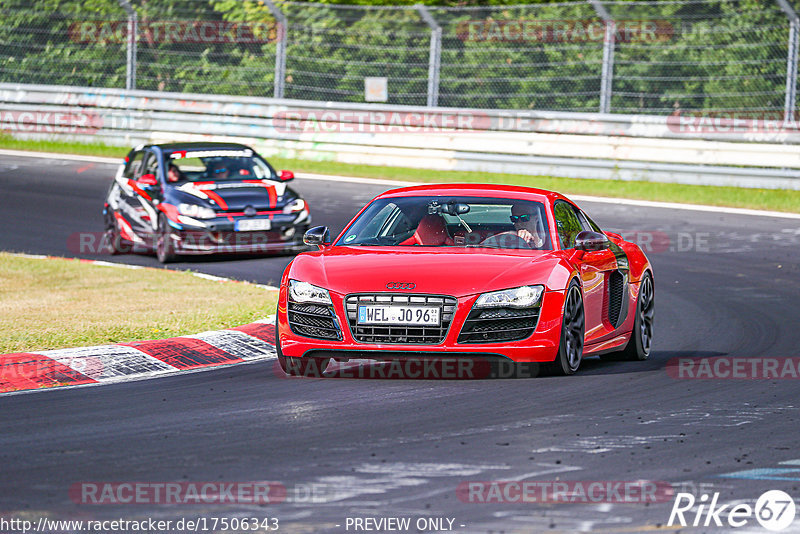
[0,134,800,213]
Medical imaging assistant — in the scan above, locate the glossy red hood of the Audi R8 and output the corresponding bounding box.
[289,246,561,297]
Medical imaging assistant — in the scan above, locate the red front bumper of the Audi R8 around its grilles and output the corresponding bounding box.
[276,287,564,362]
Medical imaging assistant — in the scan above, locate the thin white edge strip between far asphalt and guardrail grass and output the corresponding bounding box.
[0,149,800,219]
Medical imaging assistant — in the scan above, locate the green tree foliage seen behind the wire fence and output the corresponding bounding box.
[0,0,800,116]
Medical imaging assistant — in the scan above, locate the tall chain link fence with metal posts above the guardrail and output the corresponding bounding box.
[0,0,800,116]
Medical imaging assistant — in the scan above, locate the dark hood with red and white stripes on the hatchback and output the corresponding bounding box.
[176,180,295,211]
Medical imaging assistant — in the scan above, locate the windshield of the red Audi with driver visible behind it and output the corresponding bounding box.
[336,196,552,250]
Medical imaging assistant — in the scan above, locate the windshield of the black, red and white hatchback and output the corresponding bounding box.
[165,149,277,183]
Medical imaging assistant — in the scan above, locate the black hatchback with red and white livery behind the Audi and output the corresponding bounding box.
[103,143,311,263]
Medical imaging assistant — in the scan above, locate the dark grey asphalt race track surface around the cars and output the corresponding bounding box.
[0,153,800,533]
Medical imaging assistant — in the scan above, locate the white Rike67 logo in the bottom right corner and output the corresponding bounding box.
[667,490,795,532]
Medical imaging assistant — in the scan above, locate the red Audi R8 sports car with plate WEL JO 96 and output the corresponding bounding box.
[276,184,654,375]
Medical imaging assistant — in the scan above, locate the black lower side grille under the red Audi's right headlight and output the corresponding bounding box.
[458,306,540,343]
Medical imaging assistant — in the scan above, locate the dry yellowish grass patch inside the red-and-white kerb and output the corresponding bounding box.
[0,252,277,354]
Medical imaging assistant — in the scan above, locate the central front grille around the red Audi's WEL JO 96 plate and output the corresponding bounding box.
[345,293,458,345]
